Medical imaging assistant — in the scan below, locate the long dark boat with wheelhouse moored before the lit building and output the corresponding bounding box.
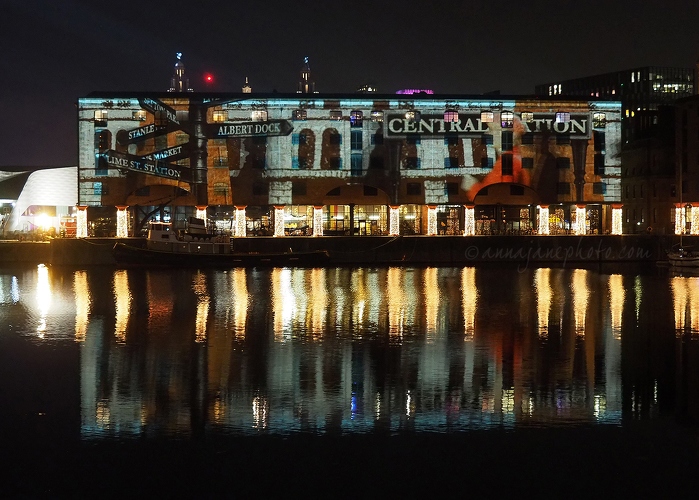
[113,219,329,267]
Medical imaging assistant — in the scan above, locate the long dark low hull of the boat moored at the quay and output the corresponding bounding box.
[112,243,330,267]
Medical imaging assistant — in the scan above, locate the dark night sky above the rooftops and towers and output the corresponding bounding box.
[0,0,699,169]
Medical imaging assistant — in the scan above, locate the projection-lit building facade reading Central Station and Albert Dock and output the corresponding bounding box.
[78,93,621,236]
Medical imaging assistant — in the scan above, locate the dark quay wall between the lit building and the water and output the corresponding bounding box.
[0,234,688,266]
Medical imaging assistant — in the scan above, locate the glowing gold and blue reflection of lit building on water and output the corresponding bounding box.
[10,268,688,435]
